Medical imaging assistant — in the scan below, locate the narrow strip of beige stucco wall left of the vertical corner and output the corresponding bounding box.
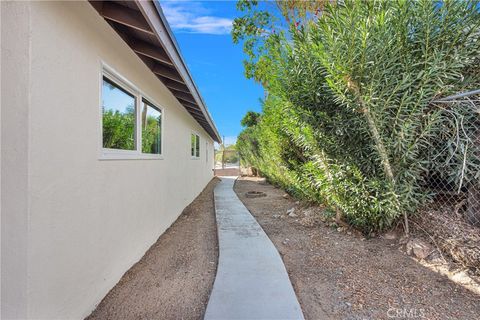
[1,2,30,319]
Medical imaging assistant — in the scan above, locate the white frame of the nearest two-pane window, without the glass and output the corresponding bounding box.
[97,62,165,160]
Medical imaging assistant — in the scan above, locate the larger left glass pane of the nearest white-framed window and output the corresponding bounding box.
[102,77,136,150]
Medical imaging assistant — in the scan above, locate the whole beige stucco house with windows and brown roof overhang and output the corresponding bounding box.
[1,1,220,319]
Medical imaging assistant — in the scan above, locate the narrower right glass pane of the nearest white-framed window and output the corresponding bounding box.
[142,100,162,154]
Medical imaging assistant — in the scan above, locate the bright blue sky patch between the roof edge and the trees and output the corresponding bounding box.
[160,1,263,144]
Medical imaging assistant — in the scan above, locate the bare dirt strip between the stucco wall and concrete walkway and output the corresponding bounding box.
[87,179,218,320]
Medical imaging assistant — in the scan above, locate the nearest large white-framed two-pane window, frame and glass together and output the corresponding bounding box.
[100,65,164,159]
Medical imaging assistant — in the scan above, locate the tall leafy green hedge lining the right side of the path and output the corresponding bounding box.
[233,0,480,233]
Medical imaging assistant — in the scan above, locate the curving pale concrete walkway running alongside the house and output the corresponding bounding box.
[205,177,303,320]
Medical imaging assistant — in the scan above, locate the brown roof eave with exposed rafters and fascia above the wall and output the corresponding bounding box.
[89,0,221,142]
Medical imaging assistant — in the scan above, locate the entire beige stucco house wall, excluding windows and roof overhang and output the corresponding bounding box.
[1,2,213,319]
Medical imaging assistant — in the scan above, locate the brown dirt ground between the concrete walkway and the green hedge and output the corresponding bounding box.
[235,178,480,319]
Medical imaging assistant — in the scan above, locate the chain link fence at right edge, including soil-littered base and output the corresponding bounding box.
[411,90,480,272]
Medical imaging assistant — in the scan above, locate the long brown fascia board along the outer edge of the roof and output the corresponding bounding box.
[136,0,221,142]
